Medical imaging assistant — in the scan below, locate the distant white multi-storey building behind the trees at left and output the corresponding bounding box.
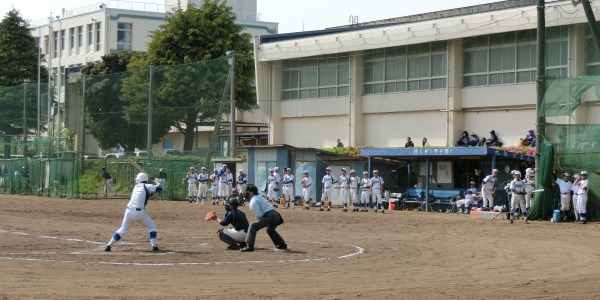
[31,0,278,154]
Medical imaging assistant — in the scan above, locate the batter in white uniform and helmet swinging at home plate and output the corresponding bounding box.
[104,173,162,252]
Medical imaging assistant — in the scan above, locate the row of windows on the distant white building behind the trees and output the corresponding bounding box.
[44,22,133,58]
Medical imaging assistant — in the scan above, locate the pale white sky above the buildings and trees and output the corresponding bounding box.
[0,0,498,33]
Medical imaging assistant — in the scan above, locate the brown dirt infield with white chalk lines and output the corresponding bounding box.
[0,195,600,299]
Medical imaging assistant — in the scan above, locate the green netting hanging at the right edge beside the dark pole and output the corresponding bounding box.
[530,77,600,219]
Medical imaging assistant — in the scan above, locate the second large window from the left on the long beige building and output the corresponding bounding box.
[364,42,447,94]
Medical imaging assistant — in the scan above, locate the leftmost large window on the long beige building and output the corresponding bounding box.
[282,55,350,100]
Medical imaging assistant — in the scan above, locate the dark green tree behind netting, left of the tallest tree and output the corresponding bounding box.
[79,52,171,152]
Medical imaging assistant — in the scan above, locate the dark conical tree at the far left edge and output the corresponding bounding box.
[0,9,48,86]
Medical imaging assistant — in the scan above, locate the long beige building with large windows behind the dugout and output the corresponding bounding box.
[255,0,600,147]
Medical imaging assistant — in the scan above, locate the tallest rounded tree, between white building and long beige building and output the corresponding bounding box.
[127,0,256,150]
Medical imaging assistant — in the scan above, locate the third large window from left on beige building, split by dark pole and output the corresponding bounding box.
[463,26,568,87]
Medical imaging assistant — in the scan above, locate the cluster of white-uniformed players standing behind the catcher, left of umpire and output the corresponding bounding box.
[183,164,248,205]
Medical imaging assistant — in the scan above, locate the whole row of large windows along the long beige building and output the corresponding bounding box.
[282,26,600,100]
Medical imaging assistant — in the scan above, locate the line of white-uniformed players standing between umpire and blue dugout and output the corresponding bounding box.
[267,167,385,213]
